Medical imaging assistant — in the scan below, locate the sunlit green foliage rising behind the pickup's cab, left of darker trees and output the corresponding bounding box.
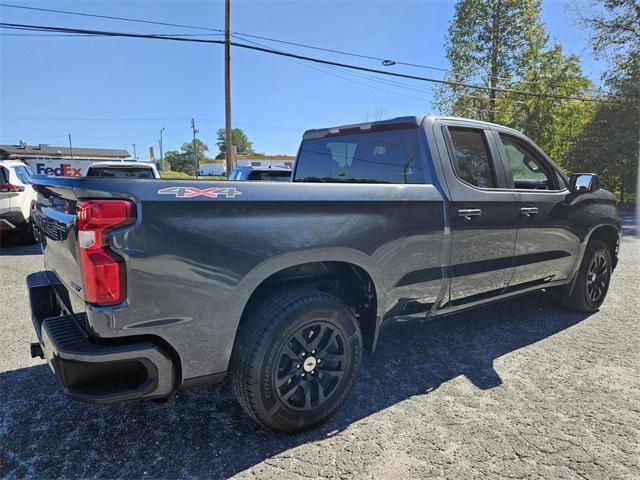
[437,0,596,175]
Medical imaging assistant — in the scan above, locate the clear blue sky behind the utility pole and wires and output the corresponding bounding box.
[0,0,605,158]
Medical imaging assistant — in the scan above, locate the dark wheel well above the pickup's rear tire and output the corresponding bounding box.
[240,262,378,350]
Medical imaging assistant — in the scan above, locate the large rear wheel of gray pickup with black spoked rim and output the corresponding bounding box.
[230,289,362,434]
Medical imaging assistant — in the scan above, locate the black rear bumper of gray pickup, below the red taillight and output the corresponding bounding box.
[27,271,176,403]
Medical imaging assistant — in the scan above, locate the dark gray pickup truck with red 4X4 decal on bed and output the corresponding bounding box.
[27,116,620,433]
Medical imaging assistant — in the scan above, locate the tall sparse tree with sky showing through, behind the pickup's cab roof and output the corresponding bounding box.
[436,0,546,121]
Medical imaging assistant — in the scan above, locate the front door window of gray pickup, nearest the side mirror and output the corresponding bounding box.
[500,134,554,190]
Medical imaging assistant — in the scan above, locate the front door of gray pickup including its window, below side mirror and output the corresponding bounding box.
[494,132,579,289]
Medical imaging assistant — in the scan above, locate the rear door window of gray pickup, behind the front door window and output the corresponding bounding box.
[448,127,496,188]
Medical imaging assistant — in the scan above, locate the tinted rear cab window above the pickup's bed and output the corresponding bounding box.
[294,128,425,184]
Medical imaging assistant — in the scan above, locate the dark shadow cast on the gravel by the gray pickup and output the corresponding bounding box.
[0,293,586,478]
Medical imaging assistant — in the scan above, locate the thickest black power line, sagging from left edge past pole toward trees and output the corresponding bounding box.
[0,23,607,102]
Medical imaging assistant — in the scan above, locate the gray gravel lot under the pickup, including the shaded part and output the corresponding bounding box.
[0,211,640,479]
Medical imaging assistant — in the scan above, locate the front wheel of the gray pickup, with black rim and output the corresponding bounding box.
[557,240,612,313]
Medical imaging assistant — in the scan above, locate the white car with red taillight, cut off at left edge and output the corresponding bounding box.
[0,160,37,244]
